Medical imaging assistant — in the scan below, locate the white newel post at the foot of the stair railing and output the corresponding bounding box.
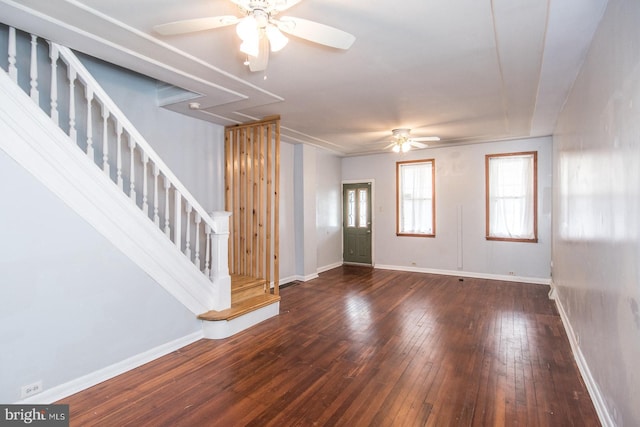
[210,211,231,310]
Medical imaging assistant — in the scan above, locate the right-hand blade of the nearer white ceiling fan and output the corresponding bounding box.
[277,16,356,50]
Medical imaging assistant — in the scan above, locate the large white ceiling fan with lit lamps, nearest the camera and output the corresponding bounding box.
[153,0,355,71]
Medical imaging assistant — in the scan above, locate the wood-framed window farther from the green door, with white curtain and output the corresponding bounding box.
[485,152,538,242]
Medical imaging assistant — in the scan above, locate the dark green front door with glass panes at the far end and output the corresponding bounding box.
[342,182,372,265]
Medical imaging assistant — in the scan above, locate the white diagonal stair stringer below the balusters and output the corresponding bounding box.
[0,72,225,315]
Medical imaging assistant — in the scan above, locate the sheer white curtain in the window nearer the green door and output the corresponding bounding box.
[400,162,433,234]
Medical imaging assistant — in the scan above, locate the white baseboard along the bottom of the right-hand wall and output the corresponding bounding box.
[549,285,616,427]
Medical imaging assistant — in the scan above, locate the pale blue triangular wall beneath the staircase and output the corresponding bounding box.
[0,151,200,403]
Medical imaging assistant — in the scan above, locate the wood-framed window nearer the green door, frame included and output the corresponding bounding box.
[396,159,436,237]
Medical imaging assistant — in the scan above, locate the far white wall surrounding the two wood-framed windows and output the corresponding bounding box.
[342,138,552,283]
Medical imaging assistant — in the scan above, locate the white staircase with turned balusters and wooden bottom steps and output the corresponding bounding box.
[0,26,279,338]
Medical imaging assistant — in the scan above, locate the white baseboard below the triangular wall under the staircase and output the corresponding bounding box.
[16,331,204,405]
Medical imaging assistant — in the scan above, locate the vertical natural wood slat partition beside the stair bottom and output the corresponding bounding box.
[225,116,280,294]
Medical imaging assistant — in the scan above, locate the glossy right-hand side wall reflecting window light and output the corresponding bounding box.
[553,0,640,426]
